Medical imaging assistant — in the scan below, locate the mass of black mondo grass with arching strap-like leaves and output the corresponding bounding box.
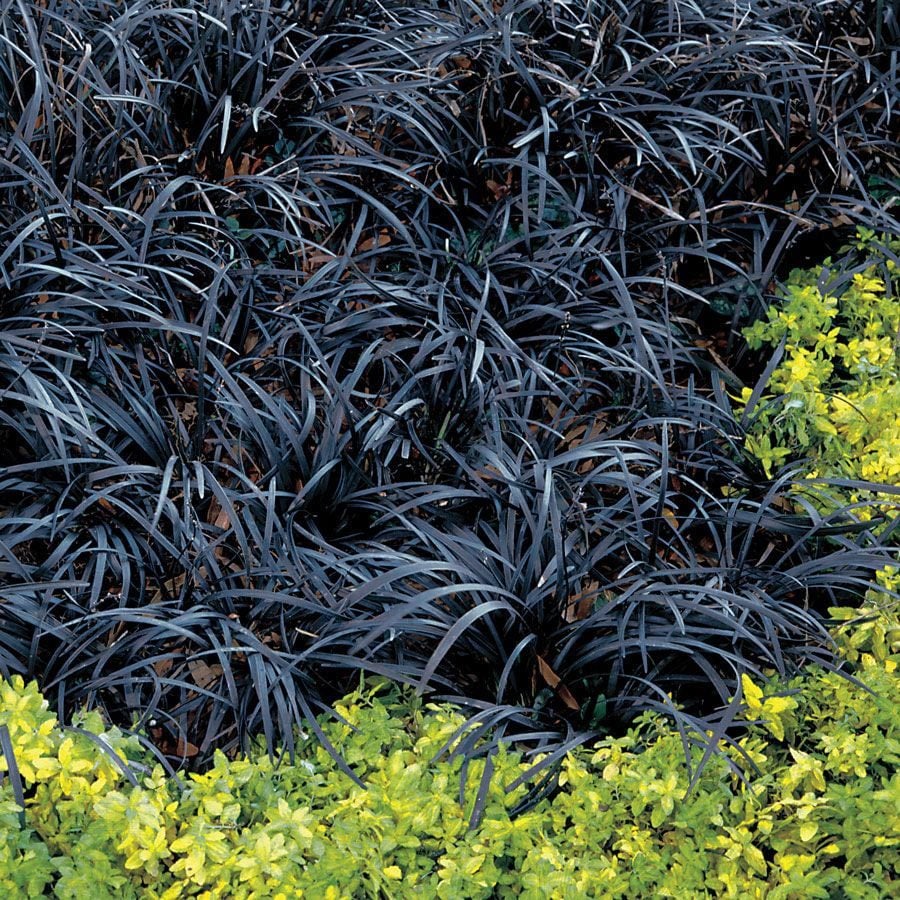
[0,0,900,808]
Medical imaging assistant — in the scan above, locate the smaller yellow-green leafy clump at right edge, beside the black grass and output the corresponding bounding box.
[740,229,900,518]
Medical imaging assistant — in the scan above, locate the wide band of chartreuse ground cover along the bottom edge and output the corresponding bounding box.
[0,596,900,900]
